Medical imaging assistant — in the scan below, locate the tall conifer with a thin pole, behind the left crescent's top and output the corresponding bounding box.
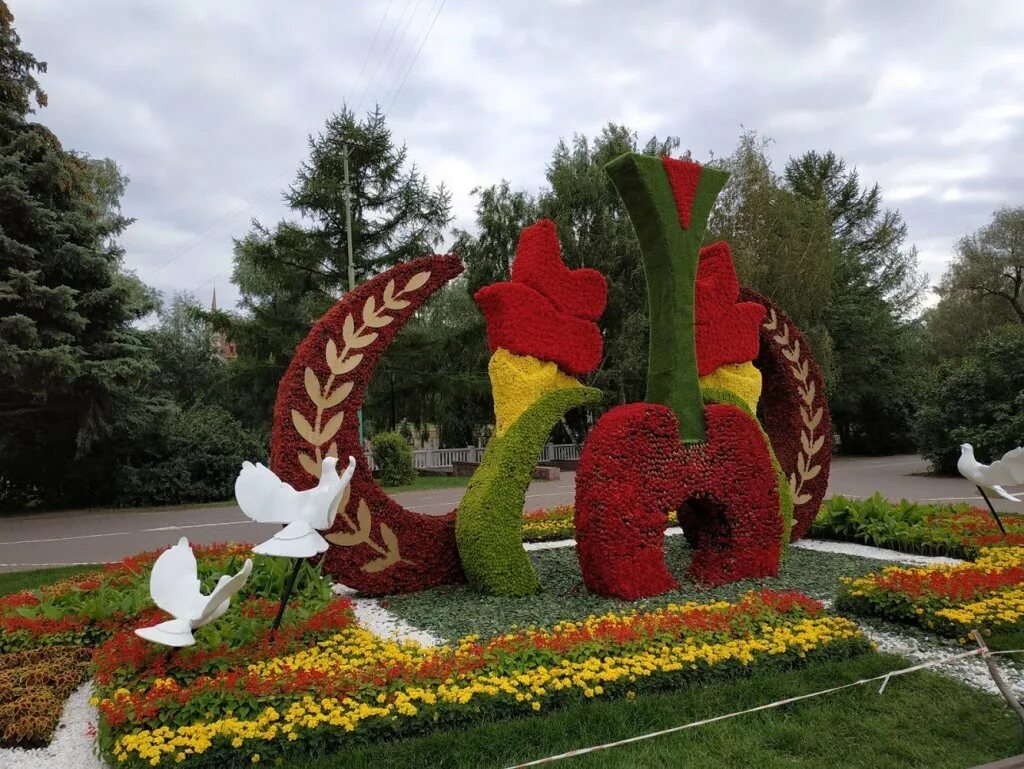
[229,108,451,423]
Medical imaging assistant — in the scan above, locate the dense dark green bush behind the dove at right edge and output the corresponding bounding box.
[915,324,1024,473]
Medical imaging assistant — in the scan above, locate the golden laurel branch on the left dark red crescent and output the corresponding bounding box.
[292,270,430,573]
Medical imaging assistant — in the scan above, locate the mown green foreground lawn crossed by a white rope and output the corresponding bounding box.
[303,654,1021,769]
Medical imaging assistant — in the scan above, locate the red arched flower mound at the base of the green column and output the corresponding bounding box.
[575,403,784,600]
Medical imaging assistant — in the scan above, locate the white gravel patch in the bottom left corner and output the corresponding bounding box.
[0,681,108,769]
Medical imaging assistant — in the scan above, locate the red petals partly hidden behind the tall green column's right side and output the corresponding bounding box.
[693,241,765,377]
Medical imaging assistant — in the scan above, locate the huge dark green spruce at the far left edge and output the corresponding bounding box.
[0,0,155,504]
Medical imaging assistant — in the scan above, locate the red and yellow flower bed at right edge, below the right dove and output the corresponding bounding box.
[837,547,1024,640]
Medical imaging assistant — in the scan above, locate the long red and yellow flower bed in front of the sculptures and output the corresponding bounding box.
[98,591,869,766]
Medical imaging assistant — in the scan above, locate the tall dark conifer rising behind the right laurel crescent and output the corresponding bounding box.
[784,152,925,454]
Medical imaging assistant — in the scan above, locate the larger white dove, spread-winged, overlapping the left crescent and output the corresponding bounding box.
[234,457,355,558]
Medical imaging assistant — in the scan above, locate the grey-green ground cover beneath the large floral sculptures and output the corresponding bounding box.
[381,537,881,639]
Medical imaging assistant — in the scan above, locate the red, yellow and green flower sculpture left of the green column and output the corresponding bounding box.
[456,220,607,596]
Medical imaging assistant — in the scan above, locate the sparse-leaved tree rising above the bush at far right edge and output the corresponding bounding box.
[939,206,1024,324]
